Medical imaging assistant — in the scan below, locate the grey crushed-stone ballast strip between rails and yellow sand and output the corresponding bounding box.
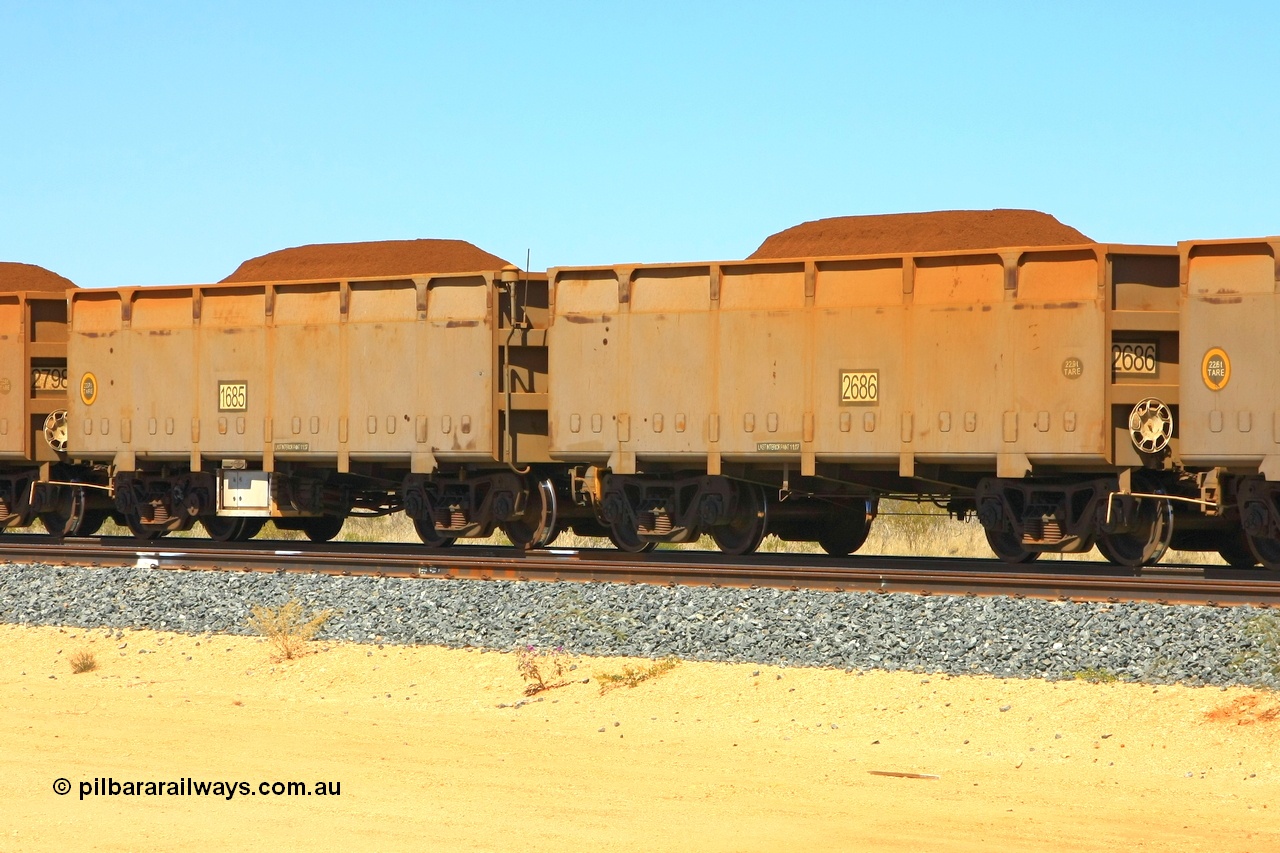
[0,565,1280,688]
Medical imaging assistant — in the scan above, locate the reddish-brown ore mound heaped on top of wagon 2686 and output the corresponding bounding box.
[750,209,1093,260]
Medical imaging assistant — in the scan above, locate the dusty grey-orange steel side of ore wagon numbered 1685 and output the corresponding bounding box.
[69,273,499,473]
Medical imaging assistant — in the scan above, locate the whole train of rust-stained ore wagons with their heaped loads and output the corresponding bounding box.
[0,211,1280,569]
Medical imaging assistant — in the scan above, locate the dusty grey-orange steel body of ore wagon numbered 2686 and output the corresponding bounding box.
[549,245,1178,476]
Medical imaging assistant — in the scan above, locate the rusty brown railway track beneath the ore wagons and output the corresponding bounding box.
[0,535,1280,607]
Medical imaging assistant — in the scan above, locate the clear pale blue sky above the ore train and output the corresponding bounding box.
[0,0,1280,287]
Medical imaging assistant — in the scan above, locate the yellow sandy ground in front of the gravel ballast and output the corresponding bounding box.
[0,626,1280,852]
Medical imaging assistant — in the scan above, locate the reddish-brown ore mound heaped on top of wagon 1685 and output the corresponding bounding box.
[223,240,511,282]
